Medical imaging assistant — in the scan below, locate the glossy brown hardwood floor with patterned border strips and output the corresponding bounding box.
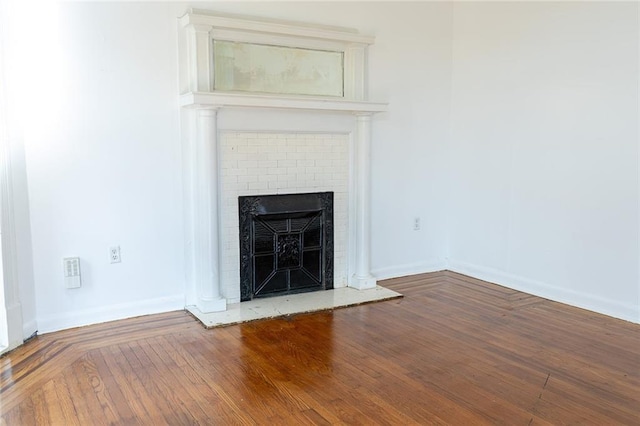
[0,272,640,425]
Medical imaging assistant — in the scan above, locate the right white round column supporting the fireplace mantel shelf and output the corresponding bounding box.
[349,112,376,290]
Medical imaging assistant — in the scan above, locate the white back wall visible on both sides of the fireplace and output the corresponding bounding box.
[26,2,451,332]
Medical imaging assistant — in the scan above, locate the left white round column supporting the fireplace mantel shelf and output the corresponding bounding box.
[192,107,227,313]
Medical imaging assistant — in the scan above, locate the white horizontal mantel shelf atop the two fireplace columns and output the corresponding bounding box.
[180,92,387,114]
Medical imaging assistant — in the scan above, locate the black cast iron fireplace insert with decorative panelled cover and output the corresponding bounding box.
[238,192,333,302]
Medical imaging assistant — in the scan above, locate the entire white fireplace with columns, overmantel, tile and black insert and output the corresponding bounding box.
[178,10,387,313]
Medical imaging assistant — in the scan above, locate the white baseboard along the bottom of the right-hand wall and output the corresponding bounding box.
[448,259,640,323]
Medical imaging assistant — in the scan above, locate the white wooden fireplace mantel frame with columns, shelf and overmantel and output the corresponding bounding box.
[179,11,387,313]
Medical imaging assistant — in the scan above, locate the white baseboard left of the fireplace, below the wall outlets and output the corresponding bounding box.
[38,294,185,334]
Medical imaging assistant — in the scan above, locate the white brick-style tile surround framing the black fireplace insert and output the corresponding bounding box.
[219,131,350,303]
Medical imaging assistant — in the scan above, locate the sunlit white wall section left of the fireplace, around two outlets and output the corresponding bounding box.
[26,3,184,332]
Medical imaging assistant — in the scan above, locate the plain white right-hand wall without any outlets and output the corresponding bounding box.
[449,2,640,321]
